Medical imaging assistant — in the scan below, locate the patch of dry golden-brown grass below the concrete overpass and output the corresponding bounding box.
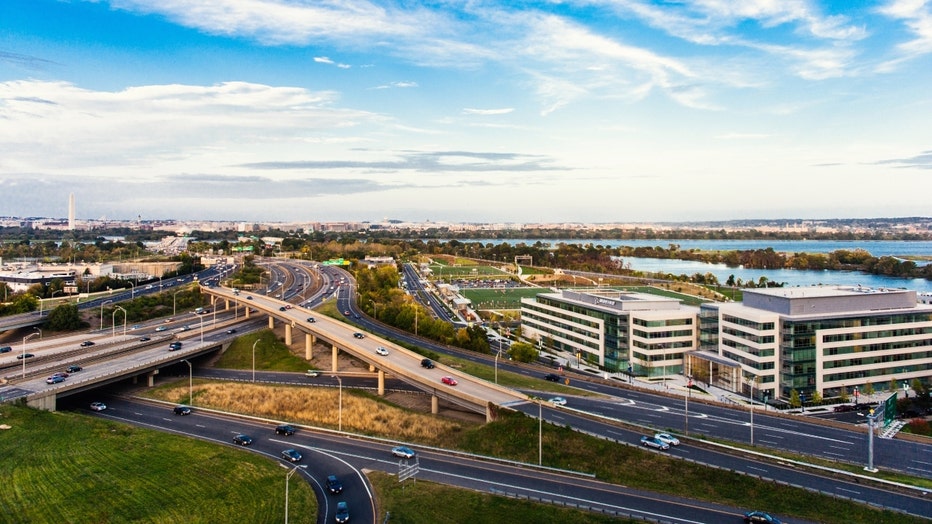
[146,380,472,445]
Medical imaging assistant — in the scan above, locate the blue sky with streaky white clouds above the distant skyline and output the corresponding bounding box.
[0,0,932,223]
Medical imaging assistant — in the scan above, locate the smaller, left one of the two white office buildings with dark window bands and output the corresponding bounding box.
[521,289,698,377]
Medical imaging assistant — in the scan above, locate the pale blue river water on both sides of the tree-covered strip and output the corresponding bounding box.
[440,239,932,293]
